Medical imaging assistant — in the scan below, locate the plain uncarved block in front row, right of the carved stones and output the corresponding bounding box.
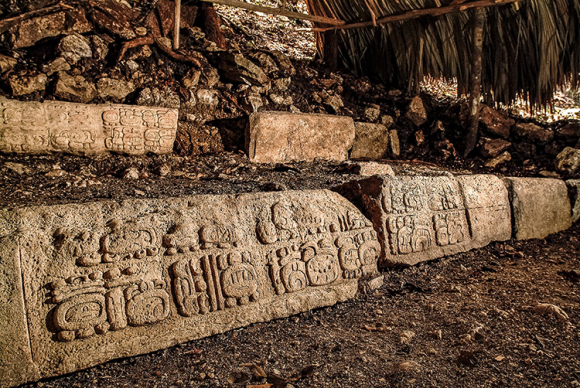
[504,178,572,240]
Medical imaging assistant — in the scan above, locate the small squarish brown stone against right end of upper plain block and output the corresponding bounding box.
[350,122,389,159]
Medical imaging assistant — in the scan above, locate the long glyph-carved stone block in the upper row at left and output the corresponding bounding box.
[0,99,178,155]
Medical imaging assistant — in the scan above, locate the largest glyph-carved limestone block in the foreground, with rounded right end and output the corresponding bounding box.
[0,191,380,386]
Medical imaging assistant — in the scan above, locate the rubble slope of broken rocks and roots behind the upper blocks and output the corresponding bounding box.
[0,0,580,177]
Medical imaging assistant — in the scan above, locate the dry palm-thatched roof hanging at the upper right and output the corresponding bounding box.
[306,0,580,106]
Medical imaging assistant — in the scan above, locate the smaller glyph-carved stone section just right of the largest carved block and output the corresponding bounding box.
[337,175,511,266]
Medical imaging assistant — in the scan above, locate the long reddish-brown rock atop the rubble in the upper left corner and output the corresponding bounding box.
[8,9,92,49]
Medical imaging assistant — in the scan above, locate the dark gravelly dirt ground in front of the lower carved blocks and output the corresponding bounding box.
[19,218,580,388]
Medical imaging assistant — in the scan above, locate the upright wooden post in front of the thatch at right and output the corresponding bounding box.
[463,8,485,158]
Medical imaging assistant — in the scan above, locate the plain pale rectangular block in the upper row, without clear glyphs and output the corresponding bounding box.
[246,112,355,163]
